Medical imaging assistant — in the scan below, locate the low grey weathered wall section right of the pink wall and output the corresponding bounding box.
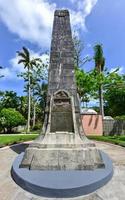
[103,119,125,135]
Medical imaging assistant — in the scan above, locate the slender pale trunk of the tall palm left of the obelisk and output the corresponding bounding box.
[27,70,31,133]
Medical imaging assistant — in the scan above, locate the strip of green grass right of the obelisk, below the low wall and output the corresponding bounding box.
[88,135,125,147]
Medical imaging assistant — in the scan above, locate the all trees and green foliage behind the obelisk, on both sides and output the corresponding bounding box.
[0,36,125,132]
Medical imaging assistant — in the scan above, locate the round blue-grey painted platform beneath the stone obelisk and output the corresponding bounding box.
[11,151,113,198]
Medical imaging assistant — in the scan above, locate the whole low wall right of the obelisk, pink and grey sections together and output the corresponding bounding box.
[81,114,125,135]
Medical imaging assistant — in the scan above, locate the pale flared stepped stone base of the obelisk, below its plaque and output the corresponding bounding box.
[20,132,104,170]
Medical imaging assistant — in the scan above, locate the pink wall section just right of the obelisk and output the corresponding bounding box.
[81,114,103,135]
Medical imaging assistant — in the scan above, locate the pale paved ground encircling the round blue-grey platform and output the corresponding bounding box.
[0,142,125,200]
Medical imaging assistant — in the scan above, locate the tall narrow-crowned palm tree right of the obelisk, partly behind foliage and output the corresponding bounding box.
[94,44,105,118]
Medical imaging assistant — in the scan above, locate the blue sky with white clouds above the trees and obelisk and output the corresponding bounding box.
[0,0,125,95]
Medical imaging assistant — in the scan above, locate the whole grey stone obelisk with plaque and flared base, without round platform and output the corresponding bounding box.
[20,10,104,170]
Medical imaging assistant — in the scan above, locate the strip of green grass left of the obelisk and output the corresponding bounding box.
[0,133,38,147]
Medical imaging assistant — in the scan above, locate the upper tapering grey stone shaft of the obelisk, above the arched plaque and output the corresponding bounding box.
[48,10,76,95]
